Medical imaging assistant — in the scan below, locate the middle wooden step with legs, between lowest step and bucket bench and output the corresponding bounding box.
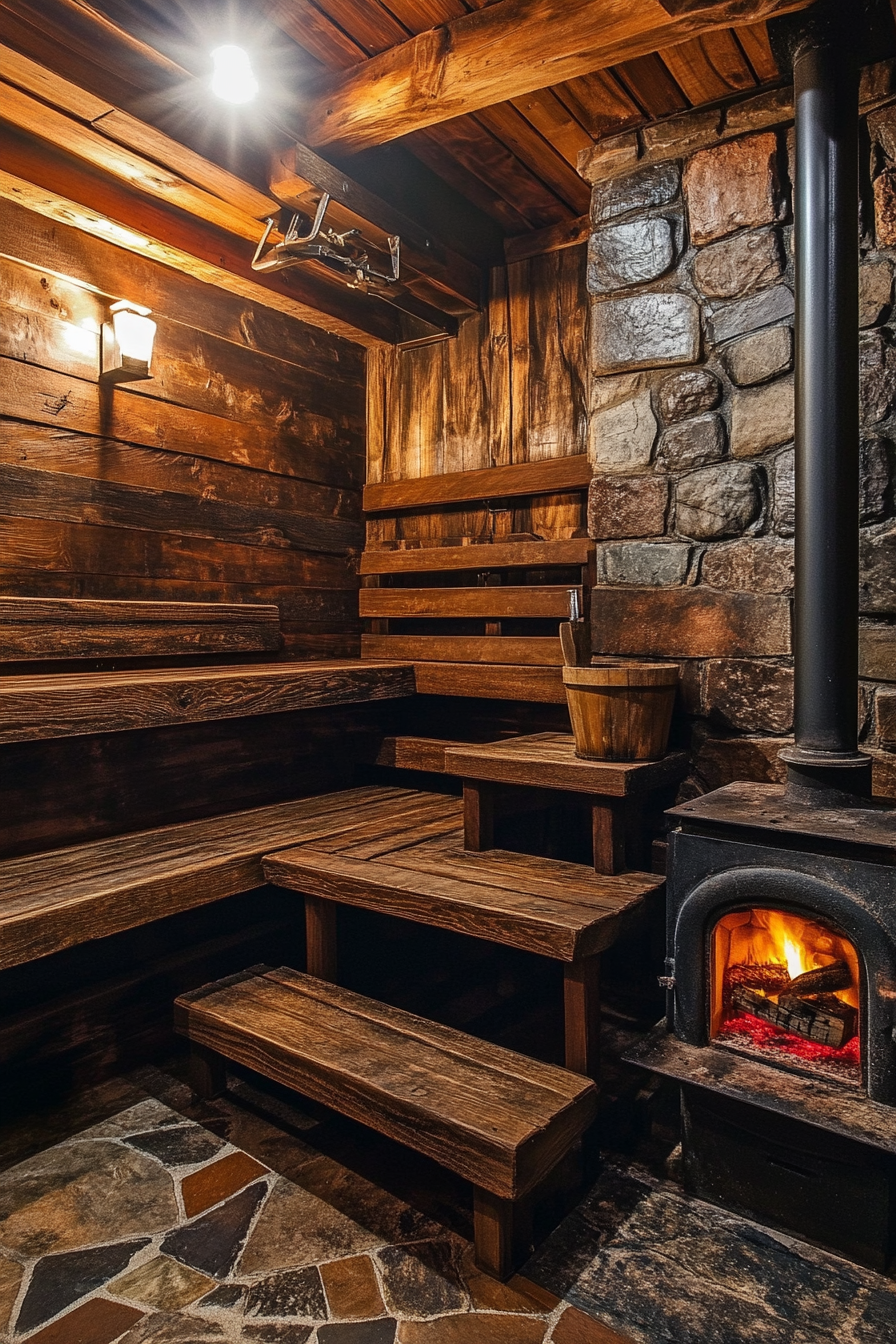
[263,790,662,1077]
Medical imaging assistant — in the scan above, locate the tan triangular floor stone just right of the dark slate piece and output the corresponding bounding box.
[239,1177,382,1274]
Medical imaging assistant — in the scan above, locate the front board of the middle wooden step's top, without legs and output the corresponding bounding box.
[265,847,647,961]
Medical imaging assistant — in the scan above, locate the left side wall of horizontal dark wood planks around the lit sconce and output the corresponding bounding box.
[0,204,365,657]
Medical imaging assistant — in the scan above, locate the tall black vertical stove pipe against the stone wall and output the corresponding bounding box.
[780,0,870,806]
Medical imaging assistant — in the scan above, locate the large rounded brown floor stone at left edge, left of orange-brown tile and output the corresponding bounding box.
[0,1140,177,1255]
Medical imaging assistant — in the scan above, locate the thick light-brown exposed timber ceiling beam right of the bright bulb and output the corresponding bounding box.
[304,0,811,153]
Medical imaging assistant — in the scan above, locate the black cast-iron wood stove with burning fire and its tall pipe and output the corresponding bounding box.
[629,0,896,1267]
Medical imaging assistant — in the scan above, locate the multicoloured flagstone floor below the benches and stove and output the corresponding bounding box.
[0,1070,896,1344]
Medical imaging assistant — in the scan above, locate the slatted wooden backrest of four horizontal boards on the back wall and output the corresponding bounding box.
[360,456,594,704]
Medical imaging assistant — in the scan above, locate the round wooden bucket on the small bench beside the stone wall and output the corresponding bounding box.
[563,663,678,761]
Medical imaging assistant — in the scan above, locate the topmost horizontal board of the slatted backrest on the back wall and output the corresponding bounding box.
[364,453,591,513]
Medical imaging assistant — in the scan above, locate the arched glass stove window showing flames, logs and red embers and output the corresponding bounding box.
[711,907,861,1086]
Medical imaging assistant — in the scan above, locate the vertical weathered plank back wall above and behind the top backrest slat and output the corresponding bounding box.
[367,246,588,547]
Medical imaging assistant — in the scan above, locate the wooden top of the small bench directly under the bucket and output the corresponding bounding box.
[445,732,688,798]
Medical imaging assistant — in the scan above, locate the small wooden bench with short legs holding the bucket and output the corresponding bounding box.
[443,732,688,874]
